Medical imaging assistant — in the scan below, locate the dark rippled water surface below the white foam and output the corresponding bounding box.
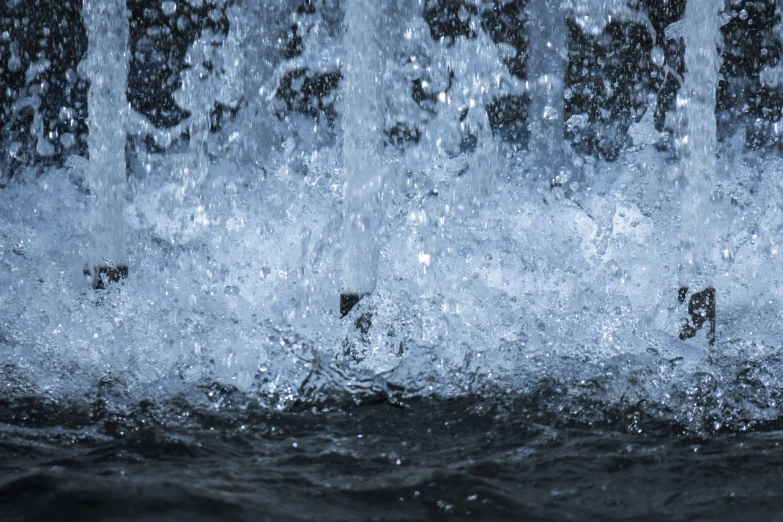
[0,398,783,522]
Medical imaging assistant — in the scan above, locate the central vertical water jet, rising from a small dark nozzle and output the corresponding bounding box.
[340,0,383,316]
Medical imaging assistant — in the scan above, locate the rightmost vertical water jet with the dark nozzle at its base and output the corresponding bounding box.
[677,0,722,344]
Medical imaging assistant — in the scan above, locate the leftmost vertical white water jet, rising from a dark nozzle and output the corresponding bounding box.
[82,0,129,289]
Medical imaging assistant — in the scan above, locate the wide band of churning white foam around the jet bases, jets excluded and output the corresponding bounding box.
[2,126,783,430]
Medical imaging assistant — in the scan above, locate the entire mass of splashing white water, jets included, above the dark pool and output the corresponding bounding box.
[0,0,783,432]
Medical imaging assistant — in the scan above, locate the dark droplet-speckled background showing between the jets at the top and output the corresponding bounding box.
[0,0,783,184]
